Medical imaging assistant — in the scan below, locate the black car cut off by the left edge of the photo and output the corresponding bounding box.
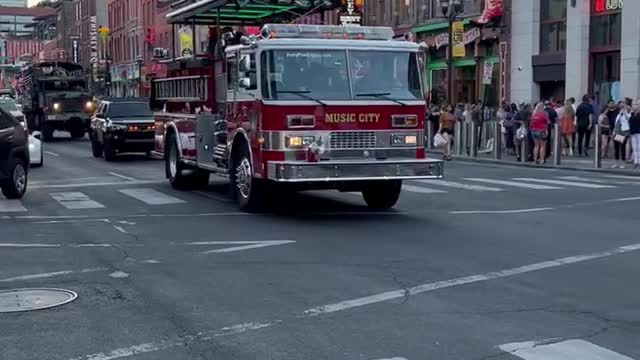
[0,109,29,199]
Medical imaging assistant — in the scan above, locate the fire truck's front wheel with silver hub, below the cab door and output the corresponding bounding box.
[229,144,266,212]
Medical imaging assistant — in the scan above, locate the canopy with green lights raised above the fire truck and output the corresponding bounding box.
[167,0,308,26]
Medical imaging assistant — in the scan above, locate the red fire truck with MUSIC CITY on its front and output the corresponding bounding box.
[152,2,443,211]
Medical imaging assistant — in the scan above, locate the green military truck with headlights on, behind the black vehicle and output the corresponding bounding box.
[18,61,96,141]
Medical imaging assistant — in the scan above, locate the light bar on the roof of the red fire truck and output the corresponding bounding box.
[260,24,394,40]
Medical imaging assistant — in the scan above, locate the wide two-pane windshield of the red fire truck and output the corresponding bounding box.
[260,50,422,102]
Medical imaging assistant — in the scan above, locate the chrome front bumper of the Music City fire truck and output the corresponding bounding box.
[268,159,444,182]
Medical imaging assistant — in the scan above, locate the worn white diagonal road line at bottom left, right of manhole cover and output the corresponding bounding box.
[65,320,282,360]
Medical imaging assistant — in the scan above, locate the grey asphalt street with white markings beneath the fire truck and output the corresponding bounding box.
[0,138,640,360]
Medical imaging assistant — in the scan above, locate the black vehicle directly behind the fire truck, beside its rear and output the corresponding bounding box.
[89,98,155,161]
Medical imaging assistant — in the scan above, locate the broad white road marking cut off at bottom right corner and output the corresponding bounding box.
[499,339,633,360]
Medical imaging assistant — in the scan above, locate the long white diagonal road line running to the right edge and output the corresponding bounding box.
[304,243,640,316]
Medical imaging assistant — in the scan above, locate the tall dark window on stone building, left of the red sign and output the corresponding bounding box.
[540,0,567,53]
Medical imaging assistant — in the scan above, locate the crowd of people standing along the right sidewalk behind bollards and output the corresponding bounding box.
[425,95,640,168]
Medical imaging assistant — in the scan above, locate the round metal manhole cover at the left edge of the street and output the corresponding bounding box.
[0,288,78,313]
